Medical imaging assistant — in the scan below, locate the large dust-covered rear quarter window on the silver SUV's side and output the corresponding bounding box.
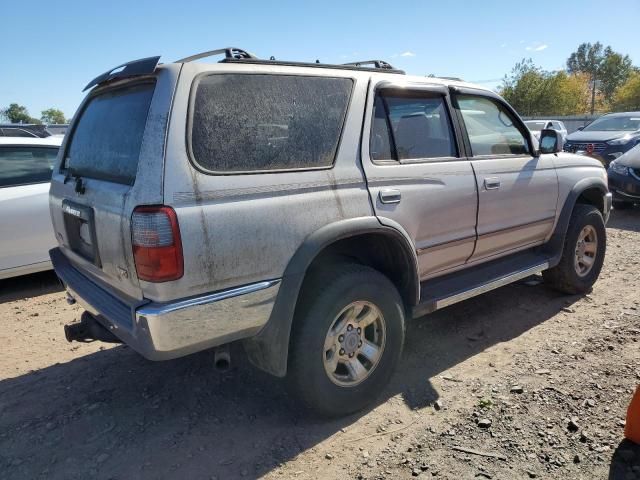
[191,74,352,173]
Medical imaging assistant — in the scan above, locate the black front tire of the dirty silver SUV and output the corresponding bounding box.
[542,204,607,295]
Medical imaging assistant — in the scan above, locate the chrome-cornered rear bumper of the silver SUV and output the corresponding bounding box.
[49,248,280,360]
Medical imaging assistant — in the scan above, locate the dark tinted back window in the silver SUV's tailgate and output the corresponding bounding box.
[64,83,155,185]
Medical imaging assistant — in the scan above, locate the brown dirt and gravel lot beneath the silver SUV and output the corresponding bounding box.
[0,209,640,479]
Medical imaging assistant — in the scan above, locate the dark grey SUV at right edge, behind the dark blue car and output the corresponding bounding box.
[564,112,640,166]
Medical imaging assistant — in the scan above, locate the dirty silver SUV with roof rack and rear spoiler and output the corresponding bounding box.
[50,49,611,415]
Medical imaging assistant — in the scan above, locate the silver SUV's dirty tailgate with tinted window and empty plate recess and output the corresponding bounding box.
[49,67,179,299]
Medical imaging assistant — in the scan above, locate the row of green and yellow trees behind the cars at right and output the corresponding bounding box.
[500,42,640,116]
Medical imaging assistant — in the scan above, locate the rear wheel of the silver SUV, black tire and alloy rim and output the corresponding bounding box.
[287,263,405,417]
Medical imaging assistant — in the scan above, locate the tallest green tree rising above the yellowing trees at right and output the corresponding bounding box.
[567,42,633,113]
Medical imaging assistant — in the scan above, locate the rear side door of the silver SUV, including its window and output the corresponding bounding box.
[362,82,477,279]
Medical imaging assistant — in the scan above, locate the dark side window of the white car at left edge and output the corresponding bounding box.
[0,147,58,187]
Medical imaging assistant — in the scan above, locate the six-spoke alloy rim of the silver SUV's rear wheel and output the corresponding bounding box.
[322,301,386,387]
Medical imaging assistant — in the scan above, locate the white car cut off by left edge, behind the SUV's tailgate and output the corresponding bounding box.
[0,137,62,279]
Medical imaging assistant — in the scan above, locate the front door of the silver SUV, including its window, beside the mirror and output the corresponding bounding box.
[454,89,558,262]
